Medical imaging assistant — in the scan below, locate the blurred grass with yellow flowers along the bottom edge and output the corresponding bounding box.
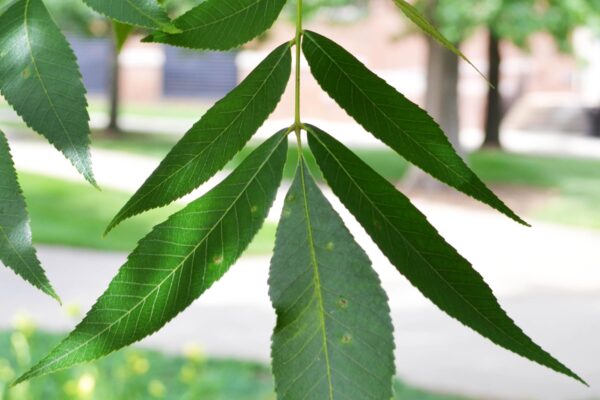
[0,323,465,400]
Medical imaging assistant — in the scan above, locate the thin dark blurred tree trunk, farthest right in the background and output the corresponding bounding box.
[483,29,504,148]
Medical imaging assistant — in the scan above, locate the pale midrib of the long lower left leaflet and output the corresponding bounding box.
[29,135,287,380]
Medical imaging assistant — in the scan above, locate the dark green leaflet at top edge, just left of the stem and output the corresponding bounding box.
[144,0,286,50]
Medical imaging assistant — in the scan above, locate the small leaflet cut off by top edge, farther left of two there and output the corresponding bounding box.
[83,0,179,33]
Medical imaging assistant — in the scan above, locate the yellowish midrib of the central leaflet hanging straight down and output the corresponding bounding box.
[300,162,333,400]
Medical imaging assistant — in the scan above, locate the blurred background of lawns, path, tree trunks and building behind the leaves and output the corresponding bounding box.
[0,0,600,400]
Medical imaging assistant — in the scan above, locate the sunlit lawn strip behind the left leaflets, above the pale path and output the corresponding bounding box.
[20,174,275,254]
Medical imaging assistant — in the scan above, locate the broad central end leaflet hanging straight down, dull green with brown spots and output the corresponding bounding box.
[269,160,394,400]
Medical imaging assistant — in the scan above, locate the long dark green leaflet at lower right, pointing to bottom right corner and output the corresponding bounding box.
[307,126,583,382]
